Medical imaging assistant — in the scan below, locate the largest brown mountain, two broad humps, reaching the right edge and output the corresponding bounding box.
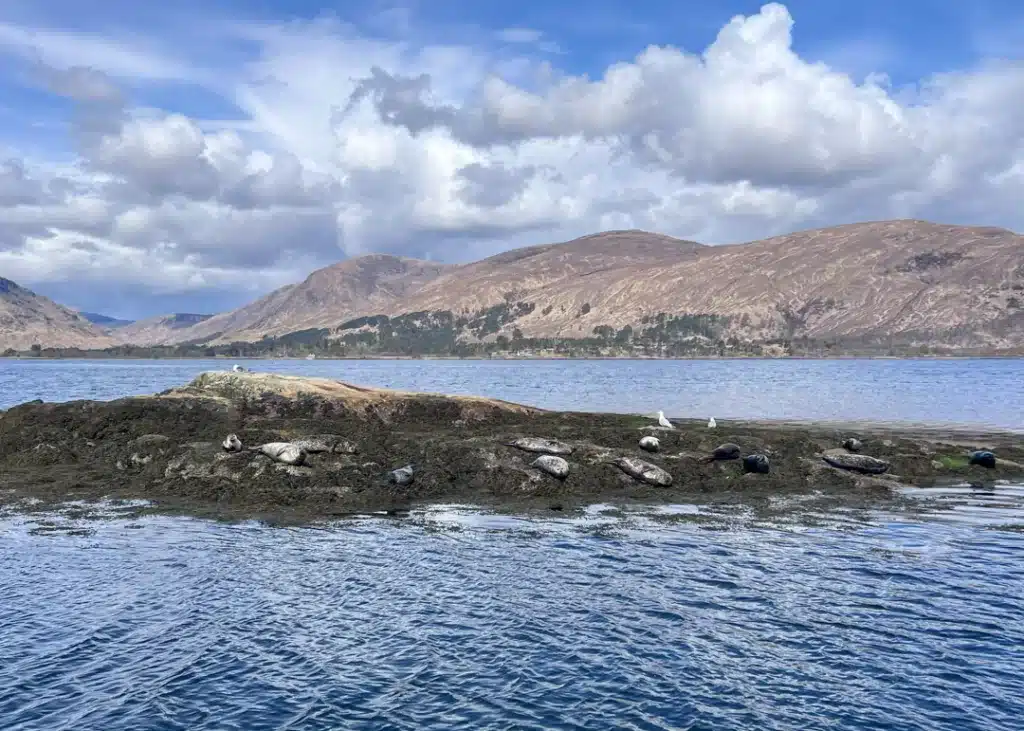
[342,220,1024,349]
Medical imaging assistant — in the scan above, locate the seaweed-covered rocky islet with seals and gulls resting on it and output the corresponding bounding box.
[0,372,1024,521]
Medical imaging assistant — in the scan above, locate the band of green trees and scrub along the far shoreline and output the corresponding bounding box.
[0,300,1024,359]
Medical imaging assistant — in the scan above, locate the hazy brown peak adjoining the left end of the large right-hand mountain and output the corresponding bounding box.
[139,254,453,345]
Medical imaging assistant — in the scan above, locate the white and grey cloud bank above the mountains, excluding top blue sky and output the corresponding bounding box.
[0,4,1024,315]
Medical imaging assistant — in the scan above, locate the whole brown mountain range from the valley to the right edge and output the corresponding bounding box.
[90,220,1024,352]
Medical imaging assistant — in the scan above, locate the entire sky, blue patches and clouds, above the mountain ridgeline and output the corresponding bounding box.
[0,0,1024,318]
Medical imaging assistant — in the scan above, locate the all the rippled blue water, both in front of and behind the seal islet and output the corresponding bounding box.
[0,360,1024,731]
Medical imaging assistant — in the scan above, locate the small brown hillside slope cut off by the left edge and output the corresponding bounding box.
[0,277,114,352]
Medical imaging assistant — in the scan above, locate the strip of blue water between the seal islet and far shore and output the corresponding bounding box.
[0,358,1024,429]
